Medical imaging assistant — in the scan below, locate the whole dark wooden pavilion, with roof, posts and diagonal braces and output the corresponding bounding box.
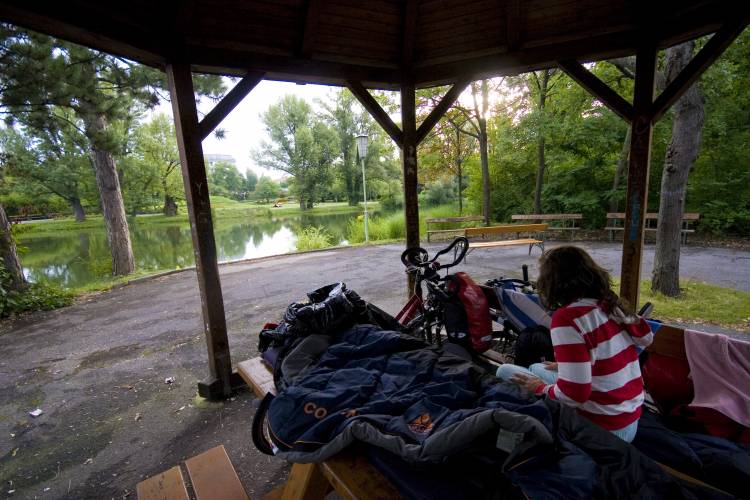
[0,0,750,397]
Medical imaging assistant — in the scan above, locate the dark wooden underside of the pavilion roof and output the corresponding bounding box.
[0,0,748,88]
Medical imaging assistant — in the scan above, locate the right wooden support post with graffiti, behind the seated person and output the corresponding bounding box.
[620,44,656,309]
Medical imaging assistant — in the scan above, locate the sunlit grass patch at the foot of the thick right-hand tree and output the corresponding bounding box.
[641,280,750,333]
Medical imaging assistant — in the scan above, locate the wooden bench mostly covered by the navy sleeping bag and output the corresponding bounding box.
[237,357,401,500]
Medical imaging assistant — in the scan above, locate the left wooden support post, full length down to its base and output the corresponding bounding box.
[166,63,232,399]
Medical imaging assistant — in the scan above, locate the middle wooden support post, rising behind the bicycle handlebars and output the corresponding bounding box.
[401,82,419,291]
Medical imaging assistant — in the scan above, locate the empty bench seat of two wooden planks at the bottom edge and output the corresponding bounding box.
[136,445,250,500]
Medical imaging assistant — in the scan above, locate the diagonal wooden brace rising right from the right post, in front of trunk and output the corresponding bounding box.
[651,17,748,123]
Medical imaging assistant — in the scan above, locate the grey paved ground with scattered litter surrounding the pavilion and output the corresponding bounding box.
[0,243,750,499]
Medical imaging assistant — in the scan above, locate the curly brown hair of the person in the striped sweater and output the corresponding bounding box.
[536,245,632,314]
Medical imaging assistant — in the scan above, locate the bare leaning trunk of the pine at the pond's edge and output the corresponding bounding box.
[86,115,135,276]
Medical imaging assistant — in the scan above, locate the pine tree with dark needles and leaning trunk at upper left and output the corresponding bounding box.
[0,25,223,275]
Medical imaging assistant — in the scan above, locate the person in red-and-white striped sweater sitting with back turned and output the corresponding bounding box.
[497,246,653,442]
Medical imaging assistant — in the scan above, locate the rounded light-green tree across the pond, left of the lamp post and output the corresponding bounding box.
[255,95,337,210]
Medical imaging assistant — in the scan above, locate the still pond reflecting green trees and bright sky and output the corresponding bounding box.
[19,213,358,288]
